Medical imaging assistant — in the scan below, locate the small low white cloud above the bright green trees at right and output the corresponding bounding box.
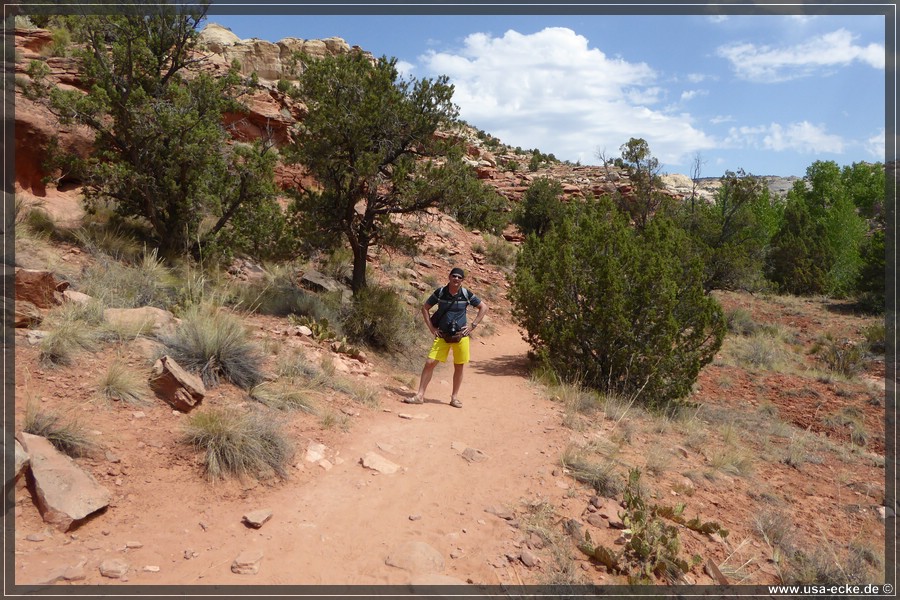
[725,121,845,154]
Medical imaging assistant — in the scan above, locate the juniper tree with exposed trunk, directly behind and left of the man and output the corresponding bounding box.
[291,52,502,293]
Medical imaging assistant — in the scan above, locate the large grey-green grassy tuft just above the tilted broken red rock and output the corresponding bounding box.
[162,305,264,390]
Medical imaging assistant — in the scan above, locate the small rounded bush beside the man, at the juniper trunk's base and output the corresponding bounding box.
[341,287,416,352]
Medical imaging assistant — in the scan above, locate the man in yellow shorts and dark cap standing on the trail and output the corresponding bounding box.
[403,267,487,408]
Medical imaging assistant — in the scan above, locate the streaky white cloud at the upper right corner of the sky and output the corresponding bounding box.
[716,29,884,82]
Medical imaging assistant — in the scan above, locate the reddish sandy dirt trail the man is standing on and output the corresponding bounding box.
[17,326,568,585]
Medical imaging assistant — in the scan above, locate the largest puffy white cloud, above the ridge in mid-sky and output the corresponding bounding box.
[420,27,713,164]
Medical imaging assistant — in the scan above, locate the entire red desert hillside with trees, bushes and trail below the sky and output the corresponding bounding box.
[6,11,895,586]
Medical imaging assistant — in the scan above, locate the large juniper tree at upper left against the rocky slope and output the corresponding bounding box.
[33,5,274,257]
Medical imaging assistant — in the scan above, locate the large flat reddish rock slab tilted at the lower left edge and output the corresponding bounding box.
[16,431,110,531]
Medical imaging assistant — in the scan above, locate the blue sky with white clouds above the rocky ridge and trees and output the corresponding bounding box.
[208,5,893,177]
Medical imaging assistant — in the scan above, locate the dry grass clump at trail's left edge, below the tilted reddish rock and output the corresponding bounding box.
[182,408,294,480]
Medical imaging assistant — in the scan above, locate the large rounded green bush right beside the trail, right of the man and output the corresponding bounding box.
[510,198,726,407]
